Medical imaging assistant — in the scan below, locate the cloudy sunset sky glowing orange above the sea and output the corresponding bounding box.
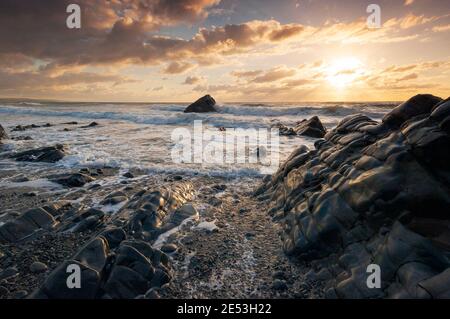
[0,0,450,103]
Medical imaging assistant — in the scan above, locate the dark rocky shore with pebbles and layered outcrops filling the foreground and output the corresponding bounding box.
[0,96,450,299]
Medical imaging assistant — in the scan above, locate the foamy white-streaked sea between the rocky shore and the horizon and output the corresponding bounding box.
[0,100,398,187]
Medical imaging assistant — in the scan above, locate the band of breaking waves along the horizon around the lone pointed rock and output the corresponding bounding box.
[0,104,387,128]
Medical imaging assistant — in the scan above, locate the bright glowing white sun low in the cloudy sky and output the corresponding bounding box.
[326,57,364,89]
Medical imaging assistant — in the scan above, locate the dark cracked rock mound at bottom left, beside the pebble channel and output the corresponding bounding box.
[29,228,172,299]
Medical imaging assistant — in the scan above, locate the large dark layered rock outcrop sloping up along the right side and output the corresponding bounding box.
[256,95,450,298]
